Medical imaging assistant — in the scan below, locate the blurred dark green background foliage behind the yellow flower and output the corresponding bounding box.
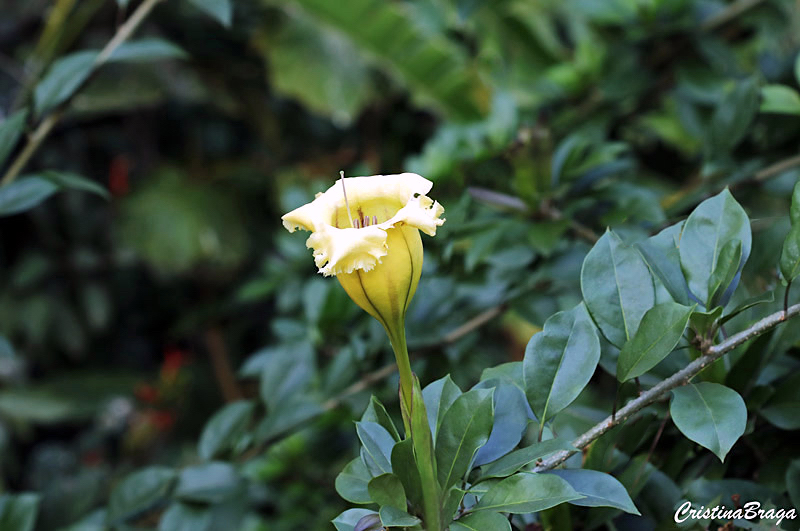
[0,0,800,530]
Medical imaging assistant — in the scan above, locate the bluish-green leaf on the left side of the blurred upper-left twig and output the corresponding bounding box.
[33,50,99,116]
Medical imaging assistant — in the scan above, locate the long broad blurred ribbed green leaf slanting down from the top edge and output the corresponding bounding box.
[286,0,489,120]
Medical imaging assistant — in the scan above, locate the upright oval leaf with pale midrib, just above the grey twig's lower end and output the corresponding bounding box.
[523,304,600,424]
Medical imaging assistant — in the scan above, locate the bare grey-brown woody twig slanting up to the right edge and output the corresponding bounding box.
[535,304,800,472]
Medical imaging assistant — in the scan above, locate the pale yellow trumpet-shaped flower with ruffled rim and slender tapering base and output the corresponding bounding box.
[282,173,444,407]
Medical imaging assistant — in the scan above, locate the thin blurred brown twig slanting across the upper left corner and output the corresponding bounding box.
[0,0,163,186]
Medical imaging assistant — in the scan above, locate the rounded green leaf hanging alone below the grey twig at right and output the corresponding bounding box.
[669,382,747,461]
